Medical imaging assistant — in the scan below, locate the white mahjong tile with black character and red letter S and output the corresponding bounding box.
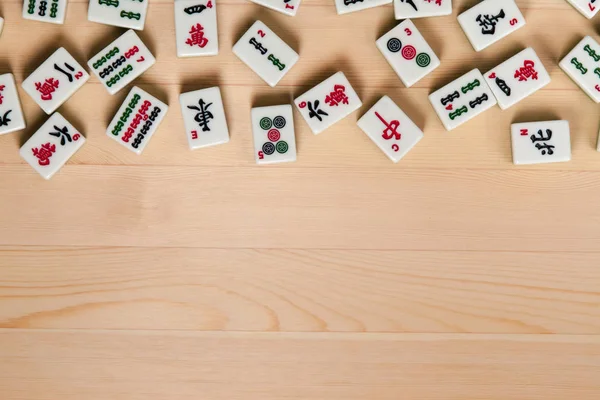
[458,0,525,51]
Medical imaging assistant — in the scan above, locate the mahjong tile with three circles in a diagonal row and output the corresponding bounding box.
[377,19,440,87]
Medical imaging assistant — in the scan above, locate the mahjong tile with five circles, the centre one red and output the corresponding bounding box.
[252,104,296,164]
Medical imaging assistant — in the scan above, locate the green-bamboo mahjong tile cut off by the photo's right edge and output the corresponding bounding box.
[559,36,600,103]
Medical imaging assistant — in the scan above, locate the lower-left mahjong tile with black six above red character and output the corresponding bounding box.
[19,113,85,179]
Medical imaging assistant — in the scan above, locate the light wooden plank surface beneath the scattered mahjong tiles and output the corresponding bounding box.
[0,0,600,400]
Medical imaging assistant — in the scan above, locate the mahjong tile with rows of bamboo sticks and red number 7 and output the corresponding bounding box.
[88,29,156,94]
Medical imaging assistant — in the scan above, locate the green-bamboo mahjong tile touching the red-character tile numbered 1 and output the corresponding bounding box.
[429,69,496,131]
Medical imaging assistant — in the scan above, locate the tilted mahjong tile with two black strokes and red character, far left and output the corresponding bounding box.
[21,47,90,114]
